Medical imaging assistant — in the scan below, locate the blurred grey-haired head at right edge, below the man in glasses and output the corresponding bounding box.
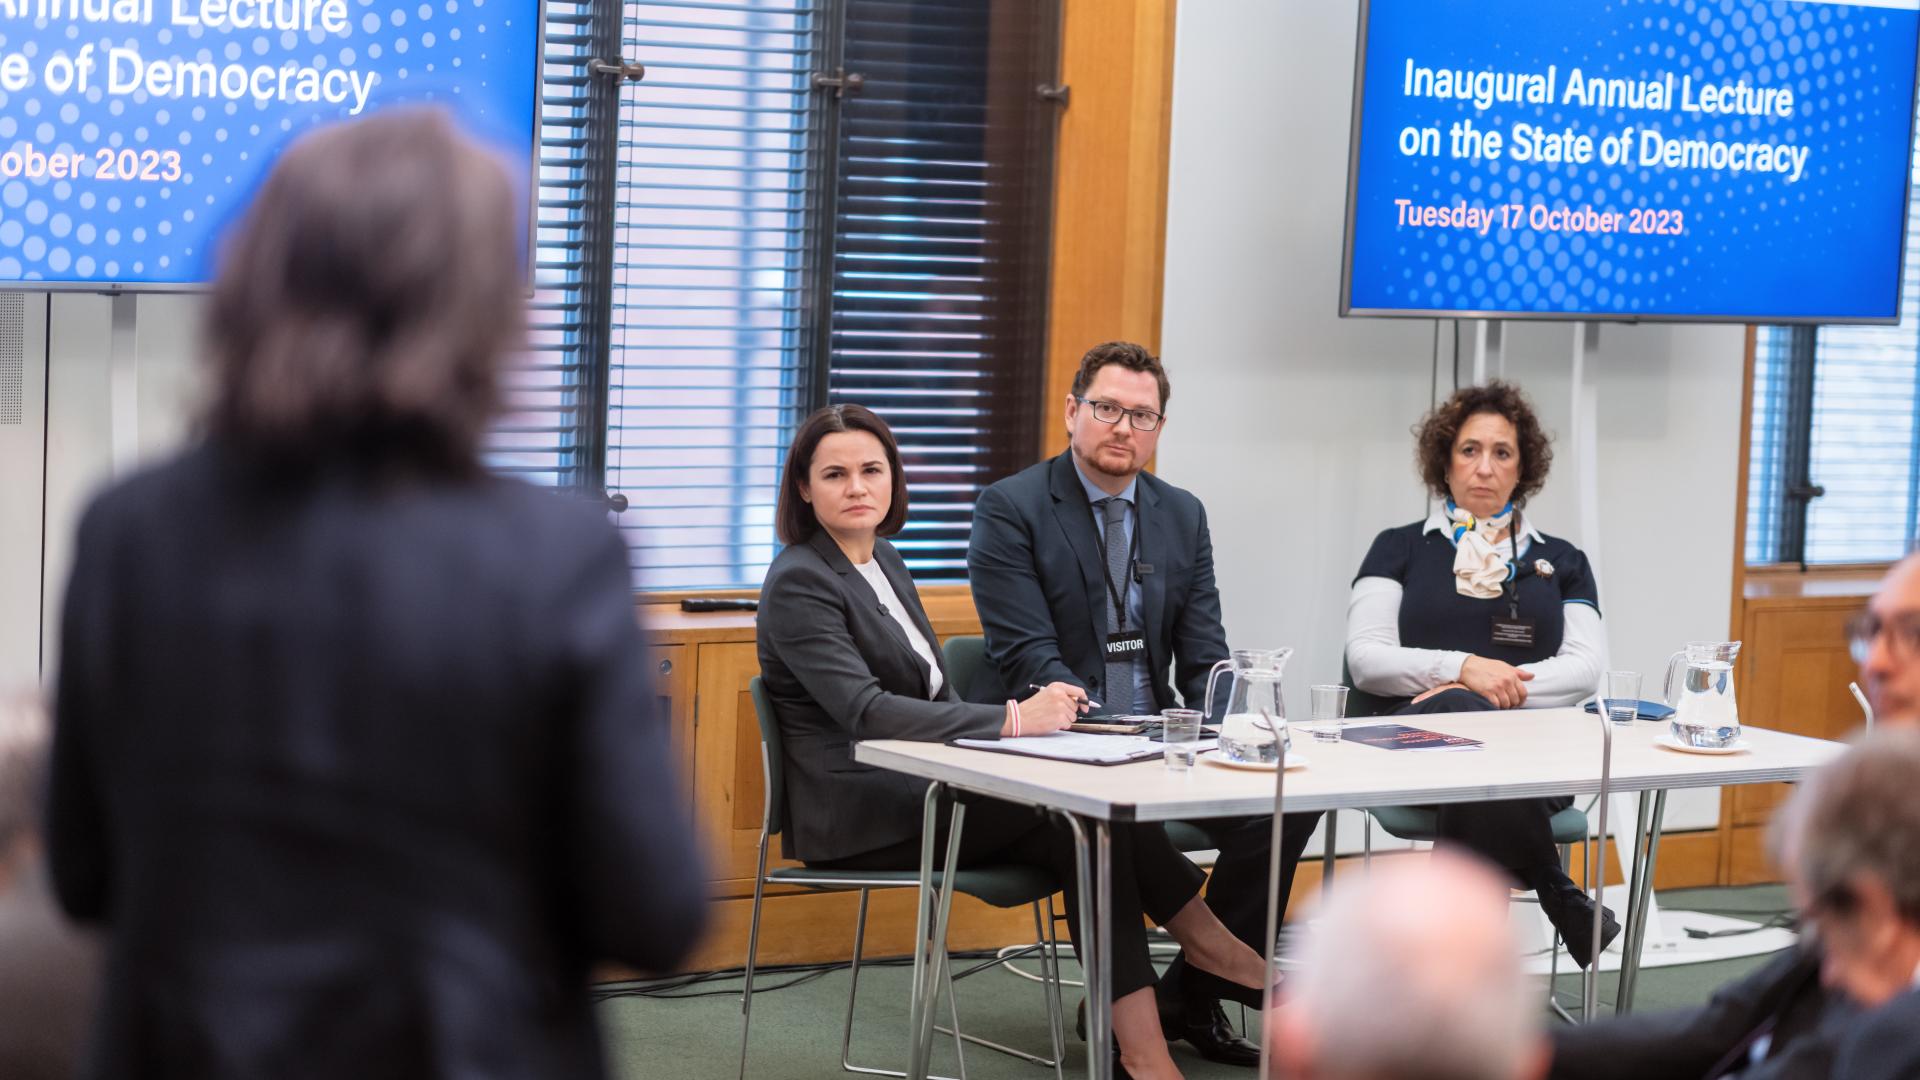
[1772,728,1920,1007]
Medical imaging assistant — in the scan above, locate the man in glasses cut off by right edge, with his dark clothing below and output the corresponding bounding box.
[1551,555,1920,1080]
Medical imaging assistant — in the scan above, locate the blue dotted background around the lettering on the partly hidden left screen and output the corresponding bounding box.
[0,0,540,286]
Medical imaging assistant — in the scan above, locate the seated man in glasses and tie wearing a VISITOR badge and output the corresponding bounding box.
[968,342,1319,1067]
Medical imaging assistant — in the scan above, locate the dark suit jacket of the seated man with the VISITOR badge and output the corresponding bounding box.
[966,450,1227,709]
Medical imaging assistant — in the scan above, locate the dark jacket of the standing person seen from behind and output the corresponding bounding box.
[48,446,707,1080]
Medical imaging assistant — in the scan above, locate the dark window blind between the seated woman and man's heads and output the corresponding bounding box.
[828,0,1058,584]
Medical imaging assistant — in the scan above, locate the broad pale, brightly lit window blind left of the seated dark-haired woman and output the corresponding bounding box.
[607,0,820,588]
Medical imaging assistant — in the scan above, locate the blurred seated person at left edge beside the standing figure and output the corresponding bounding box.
[0,696,100,1080]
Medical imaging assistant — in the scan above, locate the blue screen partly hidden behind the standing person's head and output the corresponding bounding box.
[0,0,541,290]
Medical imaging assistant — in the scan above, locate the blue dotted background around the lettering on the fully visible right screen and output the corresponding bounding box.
[1348,0,1920,321]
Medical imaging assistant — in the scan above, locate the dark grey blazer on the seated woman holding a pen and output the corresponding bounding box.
[755,530,1006,861]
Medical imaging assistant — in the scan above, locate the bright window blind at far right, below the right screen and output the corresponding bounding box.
[1747,134,1920,563]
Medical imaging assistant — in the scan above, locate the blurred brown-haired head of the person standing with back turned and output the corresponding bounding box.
[205,108,528,475]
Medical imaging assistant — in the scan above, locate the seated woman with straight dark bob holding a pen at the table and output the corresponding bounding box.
[758,405,1265,1078]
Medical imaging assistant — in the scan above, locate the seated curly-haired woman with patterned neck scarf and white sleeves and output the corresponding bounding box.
[1346,380,1619,967]
